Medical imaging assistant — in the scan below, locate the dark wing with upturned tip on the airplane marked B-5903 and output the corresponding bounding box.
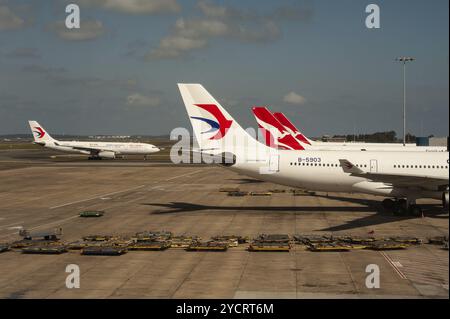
[339,159,448,190]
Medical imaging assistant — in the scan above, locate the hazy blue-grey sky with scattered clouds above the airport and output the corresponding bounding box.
[0,0,449,136]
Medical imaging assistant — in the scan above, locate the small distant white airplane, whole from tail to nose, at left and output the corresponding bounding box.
[28,121,160,159]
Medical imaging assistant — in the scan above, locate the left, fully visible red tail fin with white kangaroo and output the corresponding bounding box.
[252,107,304,150]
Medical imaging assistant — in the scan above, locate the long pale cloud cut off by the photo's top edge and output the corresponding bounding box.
[78,0,181,14]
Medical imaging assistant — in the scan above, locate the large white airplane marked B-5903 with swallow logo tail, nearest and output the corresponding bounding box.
[178,84,449,215]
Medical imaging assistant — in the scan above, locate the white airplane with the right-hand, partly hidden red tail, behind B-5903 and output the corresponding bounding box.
[273,112,447,152]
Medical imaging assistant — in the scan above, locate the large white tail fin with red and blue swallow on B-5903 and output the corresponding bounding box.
[178,83,266,159]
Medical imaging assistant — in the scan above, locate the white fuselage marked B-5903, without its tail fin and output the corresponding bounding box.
[231,151,449,199]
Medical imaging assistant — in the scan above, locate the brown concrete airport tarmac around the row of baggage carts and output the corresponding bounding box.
[0,151,449,298]
